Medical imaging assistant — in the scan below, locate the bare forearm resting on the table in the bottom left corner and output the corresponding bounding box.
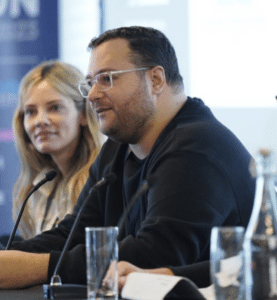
[0,251,50,289]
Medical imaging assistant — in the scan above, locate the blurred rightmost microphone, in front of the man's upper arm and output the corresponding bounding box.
[117,174,156,238]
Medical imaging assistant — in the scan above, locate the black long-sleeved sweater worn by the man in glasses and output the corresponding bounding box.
[12,98,255,283]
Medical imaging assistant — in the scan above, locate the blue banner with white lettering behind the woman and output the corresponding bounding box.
[0,0,58,235]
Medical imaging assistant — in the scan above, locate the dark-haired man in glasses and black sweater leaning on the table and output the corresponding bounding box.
[0,27,255,287]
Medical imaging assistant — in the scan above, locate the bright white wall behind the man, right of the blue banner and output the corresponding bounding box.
[60,0,277,155]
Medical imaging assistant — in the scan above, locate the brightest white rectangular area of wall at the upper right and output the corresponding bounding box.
[188,0,277,107]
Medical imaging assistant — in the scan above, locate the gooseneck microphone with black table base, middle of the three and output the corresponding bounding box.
[43,173,116,299]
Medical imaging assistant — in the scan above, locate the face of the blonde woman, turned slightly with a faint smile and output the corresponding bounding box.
[24,81,86,162]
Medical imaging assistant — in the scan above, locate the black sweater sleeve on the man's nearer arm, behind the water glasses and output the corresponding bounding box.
[116,152,237,268]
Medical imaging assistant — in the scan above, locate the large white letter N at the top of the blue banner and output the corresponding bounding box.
[10,0,40,18]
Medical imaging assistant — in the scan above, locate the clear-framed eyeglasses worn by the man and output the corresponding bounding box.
[78,67,151,98]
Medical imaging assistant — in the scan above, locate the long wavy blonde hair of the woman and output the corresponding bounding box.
[13,61,100,238]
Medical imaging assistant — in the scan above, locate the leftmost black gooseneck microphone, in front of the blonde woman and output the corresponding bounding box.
[5,169,58,250]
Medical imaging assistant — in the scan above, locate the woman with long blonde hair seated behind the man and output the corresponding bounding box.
[13,61,100,239]
